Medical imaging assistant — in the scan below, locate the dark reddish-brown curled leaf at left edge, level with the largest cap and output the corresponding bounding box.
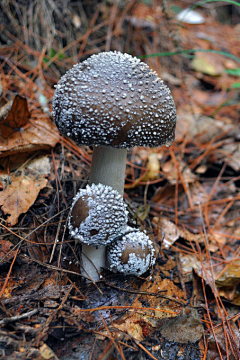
[0,95,31,139]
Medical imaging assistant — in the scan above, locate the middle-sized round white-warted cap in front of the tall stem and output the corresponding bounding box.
[68,184,128,247]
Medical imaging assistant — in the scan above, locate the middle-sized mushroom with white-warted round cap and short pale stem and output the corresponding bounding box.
[68,184,128,280]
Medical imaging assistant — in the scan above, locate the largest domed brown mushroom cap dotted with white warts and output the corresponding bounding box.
[53,51,176,148]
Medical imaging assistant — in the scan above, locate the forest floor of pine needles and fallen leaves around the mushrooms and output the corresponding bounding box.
[0,0,240,360]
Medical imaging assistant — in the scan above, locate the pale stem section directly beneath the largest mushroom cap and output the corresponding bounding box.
[90,146,127,196]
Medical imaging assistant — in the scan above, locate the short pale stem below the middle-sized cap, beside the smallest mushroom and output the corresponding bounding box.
[81,244,106,281]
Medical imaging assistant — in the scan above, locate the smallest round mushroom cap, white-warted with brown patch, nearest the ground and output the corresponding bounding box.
[107,226,155,276]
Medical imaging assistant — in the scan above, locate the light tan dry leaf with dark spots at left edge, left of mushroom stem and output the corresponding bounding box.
[0,157,50,226]
